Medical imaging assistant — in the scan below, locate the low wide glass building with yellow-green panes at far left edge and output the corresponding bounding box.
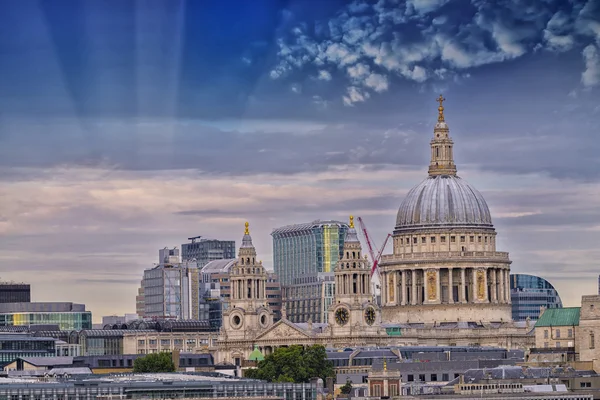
[0,302,92,330]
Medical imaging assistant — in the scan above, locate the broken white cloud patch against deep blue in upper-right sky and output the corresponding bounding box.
[271,0,600,105]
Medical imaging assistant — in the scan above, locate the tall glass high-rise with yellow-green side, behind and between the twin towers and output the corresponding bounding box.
[271,221,348,286]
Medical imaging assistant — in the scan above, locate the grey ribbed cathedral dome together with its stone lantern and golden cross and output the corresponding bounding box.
[396,96,493,232]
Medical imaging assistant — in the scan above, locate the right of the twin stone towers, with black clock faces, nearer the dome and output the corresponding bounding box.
[329,216,381,336]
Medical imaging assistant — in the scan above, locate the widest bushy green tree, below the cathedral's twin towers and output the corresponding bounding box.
[246,344,334,383]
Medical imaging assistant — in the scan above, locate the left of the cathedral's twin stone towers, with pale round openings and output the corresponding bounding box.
[223,222,273,338]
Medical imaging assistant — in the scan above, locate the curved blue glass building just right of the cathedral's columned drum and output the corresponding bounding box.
[510,274,563,321]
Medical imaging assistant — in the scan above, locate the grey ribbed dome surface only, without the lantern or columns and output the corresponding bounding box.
[396,175,492,230]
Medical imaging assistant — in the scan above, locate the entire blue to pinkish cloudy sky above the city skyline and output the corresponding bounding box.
[0,0,600,321]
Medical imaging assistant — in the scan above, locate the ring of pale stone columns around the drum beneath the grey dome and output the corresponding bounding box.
[381,267,510,306]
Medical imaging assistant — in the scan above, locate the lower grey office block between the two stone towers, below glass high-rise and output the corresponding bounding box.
[283,272,335,323]
